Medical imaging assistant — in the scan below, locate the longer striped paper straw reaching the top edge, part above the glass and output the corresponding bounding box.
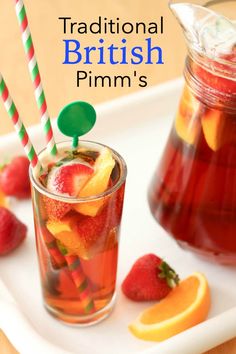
[14,0,57,155]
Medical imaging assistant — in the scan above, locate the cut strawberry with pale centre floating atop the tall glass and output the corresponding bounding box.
[47,163,94,197]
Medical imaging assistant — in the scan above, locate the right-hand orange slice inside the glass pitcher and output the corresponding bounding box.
[201,109,235,151]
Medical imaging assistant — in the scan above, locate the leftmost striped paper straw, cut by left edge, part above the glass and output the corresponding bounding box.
[0,73,42,171]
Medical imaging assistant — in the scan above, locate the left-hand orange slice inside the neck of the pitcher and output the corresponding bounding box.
[175,86,201,145]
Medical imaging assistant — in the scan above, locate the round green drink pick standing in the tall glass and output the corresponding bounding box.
[57,101,96,148]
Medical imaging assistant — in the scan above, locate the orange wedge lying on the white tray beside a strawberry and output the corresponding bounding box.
[129,273,210,341]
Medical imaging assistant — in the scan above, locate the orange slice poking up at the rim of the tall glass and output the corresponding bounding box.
[74,147,115,216]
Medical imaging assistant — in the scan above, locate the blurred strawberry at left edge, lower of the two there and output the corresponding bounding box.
[0,207,27,256]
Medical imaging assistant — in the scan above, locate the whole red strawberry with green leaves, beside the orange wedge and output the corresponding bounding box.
[122,254,179,301]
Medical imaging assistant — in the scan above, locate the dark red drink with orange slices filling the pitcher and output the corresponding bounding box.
[149,83,236,264]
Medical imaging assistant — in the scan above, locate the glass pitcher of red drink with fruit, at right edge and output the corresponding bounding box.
[148,0,236,265]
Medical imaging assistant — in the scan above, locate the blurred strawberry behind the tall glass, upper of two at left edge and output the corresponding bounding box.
[0,156,30,199]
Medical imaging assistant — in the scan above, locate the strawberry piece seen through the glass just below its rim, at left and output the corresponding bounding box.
[43,195,71,220]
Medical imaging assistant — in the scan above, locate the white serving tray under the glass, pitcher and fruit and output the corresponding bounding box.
[0,80,236,354]
